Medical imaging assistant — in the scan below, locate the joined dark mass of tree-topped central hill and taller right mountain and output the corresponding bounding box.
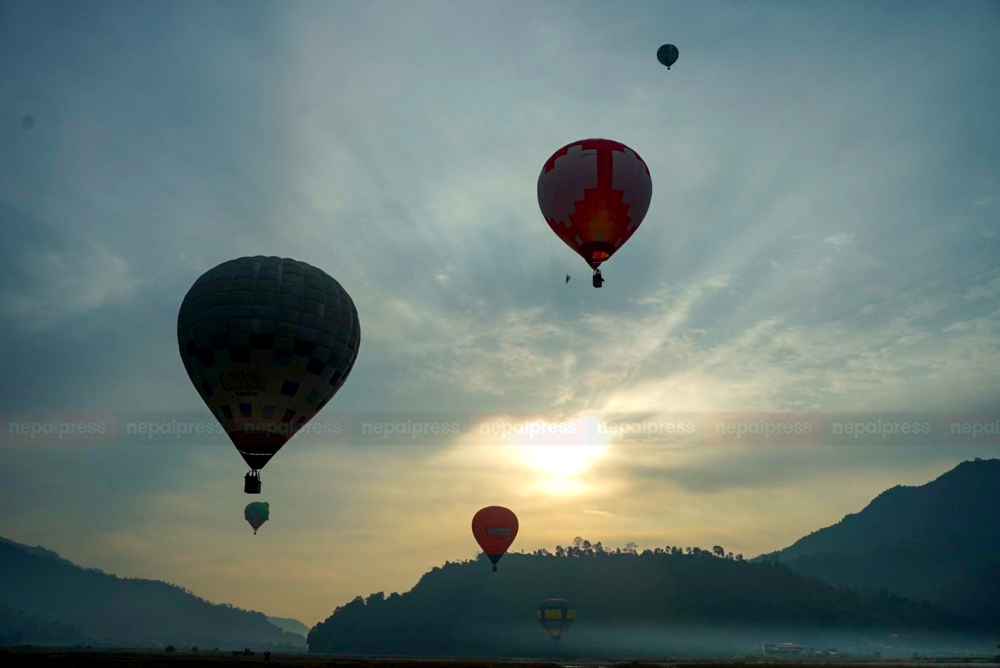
[309,460,1000,656]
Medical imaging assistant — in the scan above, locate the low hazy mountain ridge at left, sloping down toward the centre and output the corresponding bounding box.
[0,539,308,649]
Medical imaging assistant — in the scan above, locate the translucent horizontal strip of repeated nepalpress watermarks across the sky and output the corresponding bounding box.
[0,411,1000,445]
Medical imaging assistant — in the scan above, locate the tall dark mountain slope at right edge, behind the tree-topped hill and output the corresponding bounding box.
[765,459,1000,630]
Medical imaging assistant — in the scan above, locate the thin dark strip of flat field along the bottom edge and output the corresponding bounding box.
[0,647,1000,668]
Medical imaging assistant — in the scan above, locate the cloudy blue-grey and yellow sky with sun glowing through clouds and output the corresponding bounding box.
[0,0,1000,625]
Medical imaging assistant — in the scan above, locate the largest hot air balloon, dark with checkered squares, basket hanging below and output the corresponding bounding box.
[177,256,361,494]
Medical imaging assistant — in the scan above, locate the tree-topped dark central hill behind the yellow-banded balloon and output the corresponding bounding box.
[309,539,974,656]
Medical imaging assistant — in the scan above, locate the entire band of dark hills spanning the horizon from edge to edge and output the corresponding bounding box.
[0,459,1000,657]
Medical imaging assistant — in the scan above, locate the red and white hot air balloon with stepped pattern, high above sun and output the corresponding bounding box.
[538,139,653,288]
